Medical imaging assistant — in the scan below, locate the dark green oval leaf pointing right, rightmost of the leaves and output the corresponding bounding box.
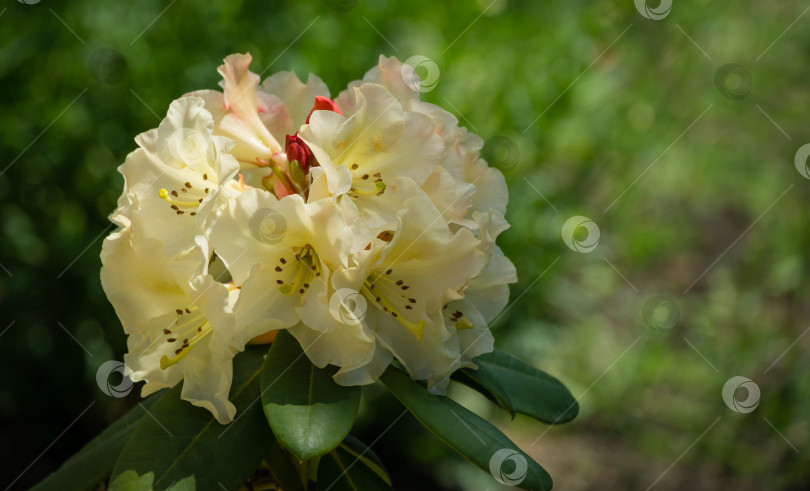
[457,350,579,424]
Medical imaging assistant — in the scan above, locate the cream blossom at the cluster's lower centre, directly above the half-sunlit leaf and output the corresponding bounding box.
[211,189,373,366]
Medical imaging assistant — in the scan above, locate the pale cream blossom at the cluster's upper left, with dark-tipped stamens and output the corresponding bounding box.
[117,97,241,257]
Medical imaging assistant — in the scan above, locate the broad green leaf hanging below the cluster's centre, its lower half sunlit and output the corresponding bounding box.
[262,331,360,461]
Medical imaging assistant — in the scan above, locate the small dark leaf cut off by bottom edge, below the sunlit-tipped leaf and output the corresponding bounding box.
[318,436,392,491]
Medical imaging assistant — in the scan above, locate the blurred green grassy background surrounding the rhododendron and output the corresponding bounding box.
[0,0,810,491]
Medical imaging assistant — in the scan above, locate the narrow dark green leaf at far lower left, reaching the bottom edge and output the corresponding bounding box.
[32,391,163,491]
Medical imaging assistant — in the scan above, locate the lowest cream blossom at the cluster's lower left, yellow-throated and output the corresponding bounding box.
[101,229,238,424]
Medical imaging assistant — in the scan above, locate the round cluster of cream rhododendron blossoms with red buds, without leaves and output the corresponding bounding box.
[101,54,516,423]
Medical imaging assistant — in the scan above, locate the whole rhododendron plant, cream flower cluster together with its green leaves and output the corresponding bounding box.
[39,54,577,489]
